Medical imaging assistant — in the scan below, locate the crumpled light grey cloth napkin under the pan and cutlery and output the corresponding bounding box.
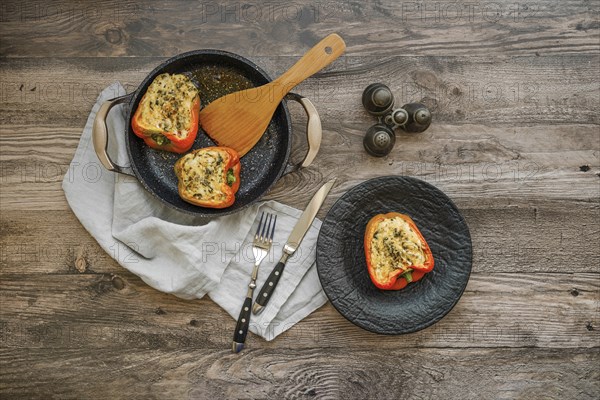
[62,82,327,340]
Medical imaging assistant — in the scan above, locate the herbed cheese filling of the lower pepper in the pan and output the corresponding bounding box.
[181,150,227,201]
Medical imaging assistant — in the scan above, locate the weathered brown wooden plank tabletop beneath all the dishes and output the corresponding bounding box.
[0,0,600,399]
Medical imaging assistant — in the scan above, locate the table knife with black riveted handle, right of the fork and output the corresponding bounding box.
[252,178,335,315]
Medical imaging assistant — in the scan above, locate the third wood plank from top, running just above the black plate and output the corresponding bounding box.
[0,125,600,211]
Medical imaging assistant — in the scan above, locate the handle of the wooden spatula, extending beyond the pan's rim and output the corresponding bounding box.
[275,33,346,94]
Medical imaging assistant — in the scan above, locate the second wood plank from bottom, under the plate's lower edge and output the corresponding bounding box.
[0,270,600,350]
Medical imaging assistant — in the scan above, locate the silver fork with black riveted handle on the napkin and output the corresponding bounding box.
[231,212,277,353]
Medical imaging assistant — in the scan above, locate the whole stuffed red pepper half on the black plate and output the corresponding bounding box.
[364,212,434,290]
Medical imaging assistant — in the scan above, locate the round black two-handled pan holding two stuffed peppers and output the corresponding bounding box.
[92,50,321,217]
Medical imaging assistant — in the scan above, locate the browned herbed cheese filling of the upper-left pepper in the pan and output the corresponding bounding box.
[138,74,198,137]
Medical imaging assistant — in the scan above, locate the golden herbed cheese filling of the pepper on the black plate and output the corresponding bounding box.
[371,217,426,281]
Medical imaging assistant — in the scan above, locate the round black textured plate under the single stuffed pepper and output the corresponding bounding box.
[317,176,472,334]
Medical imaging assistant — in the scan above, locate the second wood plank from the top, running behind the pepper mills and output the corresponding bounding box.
[0,54,600,126]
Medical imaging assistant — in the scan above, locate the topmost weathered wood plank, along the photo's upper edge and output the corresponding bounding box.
[0,0,599,57]
